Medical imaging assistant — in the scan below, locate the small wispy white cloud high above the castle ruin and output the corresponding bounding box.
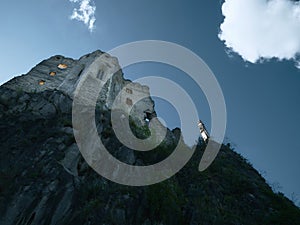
[69,0,96,31]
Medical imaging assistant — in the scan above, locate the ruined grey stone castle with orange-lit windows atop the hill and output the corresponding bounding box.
[2,50,156,125]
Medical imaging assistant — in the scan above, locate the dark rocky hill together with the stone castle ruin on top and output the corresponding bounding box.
[0,51,300,225]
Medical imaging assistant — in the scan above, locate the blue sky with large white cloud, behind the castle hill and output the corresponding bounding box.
[0,0,300,204]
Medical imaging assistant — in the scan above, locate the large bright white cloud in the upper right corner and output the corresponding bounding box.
[219,0,300,68]
